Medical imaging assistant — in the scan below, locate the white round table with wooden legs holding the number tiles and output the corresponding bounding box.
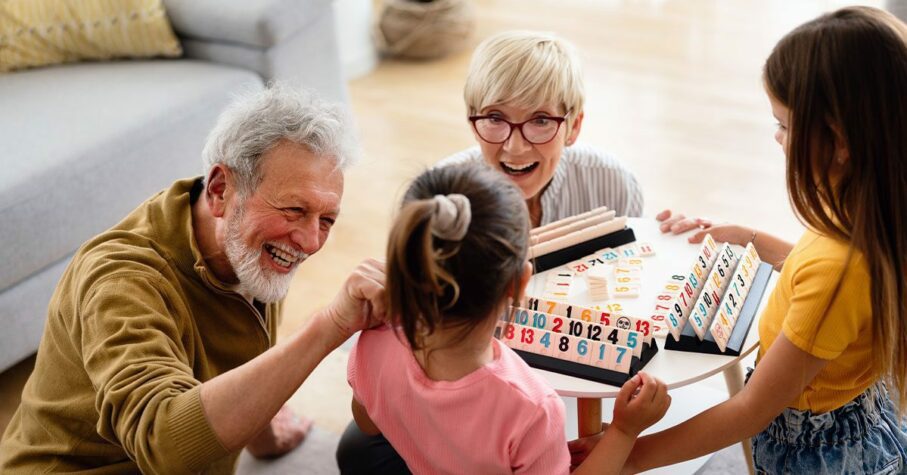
[527,218,777,473]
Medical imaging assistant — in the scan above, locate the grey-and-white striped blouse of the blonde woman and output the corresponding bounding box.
[438,144,643,225]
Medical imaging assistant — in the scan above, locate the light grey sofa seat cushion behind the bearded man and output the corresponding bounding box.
[0,60,261,289]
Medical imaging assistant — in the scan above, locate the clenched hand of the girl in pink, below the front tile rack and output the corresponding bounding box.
[611,372,671,439]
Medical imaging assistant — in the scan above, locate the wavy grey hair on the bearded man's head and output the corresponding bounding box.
[202,83,358,196]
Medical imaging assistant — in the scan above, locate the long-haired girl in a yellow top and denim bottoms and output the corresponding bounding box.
[577,7,907,473]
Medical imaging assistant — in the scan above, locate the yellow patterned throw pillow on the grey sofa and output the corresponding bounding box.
[0,0,182,71]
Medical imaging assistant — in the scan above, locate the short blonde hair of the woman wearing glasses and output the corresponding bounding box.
[463,31,585,126]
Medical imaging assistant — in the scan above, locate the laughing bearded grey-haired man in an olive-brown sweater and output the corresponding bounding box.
[0,87,384,474]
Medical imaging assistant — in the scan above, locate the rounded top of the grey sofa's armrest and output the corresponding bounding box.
[164,0,331,49]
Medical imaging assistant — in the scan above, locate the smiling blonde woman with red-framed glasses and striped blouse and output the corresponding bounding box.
[439,31,643,227]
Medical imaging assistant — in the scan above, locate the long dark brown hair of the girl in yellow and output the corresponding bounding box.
[765,7,907,413]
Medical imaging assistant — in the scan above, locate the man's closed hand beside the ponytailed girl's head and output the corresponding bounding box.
[324,259,386,341]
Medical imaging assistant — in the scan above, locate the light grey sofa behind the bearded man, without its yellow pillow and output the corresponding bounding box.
[0,0,346,371]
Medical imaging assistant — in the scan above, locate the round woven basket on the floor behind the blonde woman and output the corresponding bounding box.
[375,0,475,59]
